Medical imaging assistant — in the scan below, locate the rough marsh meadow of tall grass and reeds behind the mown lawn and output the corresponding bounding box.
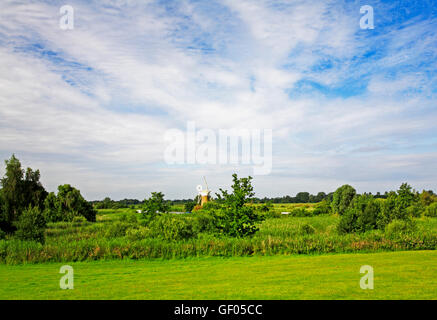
[0,204,437,264]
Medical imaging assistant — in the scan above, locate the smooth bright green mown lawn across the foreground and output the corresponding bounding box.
[0,251,437,299]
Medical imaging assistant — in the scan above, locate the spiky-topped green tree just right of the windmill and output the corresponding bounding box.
[217,174,260,237]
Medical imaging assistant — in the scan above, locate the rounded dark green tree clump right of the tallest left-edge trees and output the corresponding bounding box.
[44,184,96,222]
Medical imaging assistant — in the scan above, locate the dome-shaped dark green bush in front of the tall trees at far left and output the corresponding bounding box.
[15,207,46,243]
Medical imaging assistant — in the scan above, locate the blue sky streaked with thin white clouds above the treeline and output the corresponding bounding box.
[0,0,437,200]
